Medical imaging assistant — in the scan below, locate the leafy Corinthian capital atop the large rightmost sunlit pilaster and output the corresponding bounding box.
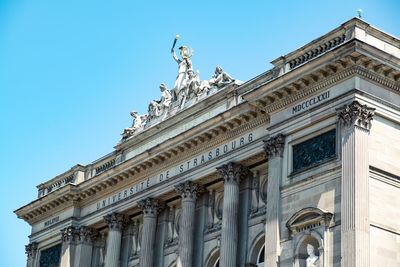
[337,101,375,131]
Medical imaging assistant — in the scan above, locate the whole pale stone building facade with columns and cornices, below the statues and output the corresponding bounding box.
[15,19,400,267]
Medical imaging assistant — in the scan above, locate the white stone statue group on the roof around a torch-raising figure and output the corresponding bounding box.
[121,35,235,141]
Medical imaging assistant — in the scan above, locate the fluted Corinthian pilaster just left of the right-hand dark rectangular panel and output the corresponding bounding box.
[264,134,285,266]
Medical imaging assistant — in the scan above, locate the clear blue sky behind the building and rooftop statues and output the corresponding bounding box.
[0,0,400,267]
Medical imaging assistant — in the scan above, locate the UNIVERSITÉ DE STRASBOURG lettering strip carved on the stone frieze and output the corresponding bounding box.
[96,129,264,213]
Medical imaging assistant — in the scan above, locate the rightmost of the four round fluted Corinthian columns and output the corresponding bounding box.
[217,162,248,267]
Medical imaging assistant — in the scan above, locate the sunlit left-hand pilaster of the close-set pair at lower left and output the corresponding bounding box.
[60,226,79,267]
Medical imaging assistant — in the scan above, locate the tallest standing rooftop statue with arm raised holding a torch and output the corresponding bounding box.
[171,35,193,100]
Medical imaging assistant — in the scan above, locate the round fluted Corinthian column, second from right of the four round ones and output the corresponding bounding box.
[175,181,204,267]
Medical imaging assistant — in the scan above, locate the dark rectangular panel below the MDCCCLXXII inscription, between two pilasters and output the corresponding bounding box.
[293,129,336,172]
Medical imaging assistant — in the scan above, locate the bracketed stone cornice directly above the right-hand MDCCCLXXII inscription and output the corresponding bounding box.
[248,52,400,114]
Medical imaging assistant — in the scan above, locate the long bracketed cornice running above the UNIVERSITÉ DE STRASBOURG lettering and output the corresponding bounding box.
[16,103,269,224]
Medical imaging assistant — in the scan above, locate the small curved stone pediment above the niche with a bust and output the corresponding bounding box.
[286,207,333,234]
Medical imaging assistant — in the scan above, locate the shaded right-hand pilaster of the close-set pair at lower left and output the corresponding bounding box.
[74,226,99,267]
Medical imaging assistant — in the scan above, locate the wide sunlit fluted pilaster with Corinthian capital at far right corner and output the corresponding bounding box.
[338,101,375,267]
